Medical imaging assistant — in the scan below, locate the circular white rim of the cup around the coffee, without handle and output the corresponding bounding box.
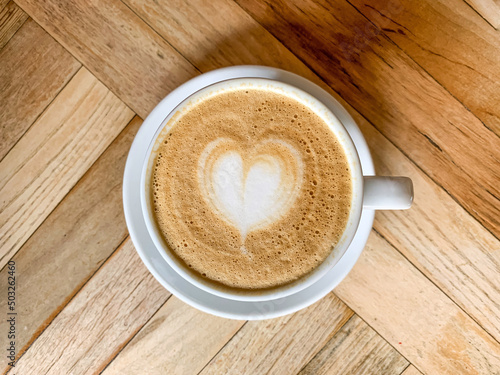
[140,77,363,301]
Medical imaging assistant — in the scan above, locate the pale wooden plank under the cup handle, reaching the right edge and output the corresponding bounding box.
[358,119,500,341]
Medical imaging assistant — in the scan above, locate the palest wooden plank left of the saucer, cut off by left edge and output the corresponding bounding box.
[0,68,133,267]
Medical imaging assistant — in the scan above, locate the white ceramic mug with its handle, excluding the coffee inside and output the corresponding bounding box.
[141,78,413,301]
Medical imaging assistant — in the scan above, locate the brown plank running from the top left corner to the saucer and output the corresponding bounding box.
[17,0,197,118]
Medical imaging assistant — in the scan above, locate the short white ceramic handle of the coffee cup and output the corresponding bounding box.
[363,176,413,210]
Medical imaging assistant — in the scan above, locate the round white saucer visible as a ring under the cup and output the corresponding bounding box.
[123,66,375,320]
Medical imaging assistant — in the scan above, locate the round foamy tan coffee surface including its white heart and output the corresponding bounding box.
[150,85,352,290]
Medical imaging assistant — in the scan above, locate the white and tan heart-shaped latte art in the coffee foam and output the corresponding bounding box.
[198,138,304,242]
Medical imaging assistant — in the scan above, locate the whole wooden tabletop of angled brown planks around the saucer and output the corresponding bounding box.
[0,0,500,375]
